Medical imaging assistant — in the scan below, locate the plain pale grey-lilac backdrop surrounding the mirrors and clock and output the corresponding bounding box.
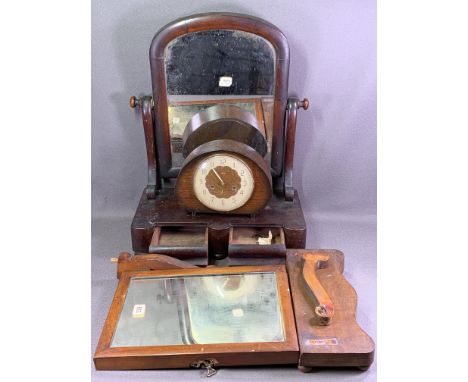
[91,0,377,381]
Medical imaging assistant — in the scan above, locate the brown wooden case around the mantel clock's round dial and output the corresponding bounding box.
[175,139,272,214]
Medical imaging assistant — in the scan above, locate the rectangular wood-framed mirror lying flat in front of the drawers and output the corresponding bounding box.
[95,265,298,369]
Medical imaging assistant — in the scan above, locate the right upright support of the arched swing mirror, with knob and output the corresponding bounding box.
[283,98,309,202]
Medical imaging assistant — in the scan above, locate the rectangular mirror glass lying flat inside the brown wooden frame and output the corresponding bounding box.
[111,272,285,347]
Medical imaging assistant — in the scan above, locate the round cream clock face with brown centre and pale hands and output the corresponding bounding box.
[193,154,254,211]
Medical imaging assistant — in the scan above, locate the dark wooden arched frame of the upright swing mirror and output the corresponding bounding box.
[150,13,289,178]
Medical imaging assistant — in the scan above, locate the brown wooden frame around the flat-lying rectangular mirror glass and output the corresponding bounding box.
[94,266,299,370]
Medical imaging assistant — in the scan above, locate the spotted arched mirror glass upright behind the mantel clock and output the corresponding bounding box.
[164,29,276,165]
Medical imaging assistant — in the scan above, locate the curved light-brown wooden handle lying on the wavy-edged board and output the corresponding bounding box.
[302,253,334,325]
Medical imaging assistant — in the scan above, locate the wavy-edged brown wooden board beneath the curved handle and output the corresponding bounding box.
[287,250,374,370]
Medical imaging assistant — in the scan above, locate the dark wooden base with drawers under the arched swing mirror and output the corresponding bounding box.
[131,189,306,258]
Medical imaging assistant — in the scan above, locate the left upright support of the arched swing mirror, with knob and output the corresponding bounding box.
[130,96,161,199]
